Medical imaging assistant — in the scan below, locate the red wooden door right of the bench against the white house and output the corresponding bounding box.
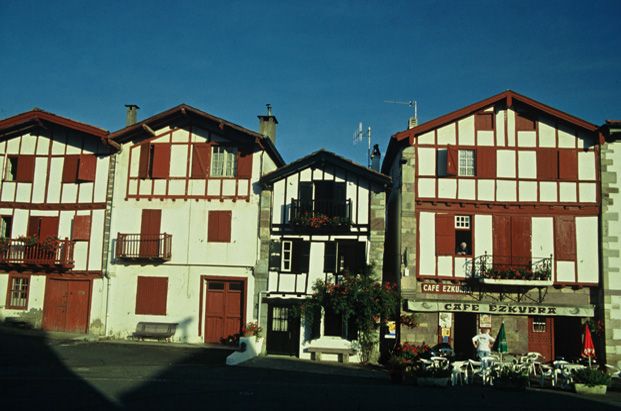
[205,280,244,343]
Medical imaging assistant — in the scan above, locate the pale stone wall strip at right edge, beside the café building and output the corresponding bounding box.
[600,141,621,366]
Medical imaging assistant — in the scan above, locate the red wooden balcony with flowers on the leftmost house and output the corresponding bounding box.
[0,237,75,270]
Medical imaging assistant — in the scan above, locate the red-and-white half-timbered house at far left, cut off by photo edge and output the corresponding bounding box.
[0,109,116,333]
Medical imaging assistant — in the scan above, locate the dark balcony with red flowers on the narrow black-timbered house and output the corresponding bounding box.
[289,199,352,230]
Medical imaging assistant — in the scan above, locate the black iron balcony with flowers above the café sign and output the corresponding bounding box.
[471,254,553,287]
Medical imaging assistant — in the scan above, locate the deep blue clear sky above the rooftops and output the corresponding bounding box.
[0,0,621,163]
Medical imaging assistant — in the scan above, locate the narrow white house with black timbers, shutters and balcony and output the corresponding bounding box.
[257,150,390,361]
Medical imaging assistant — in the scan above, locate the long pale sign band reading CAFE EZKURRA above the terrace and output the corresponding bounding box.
[407,300,594,317]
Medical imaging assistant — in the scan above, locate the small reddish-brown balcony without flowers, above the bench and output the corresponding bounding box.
[115,233,172,261]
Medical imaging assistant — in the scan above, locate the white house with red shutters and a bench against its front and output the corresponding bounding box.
[104,105,284,343]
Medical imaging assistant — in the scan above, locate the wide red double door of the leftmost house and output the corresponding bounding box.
[43,278,91,333]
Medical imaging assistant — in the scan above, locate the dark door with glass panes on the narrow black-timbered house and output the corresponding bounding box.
[266,304,300,356]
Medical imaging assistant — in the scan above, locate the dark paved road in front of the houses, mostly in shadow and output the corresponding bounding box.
[0,328,621,411]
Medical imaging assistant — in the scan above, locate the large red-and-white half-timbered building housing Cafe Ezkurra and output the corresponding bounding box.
[382,91,602,360]
